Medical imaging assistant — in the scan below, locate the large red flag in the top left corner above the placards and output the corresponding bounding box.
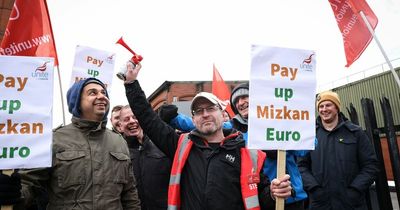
[0,0,58,65]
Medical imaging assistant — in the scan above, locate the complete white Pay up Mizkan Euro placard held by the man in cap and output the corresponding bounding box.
[248,45,316,150]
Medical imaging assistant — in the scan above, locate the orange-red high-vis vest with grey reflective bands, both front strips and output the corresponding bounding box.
[168,134,266,210]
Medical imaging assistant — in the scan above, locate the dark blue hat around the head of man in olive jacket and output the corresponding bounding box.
[67,77,108,120]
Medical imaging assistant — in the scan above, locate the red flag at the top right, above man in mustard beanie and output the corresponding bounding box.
[329,0,378,67]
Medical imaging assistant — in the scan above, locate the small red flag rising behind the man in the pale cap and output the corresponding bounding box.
[212,65,235,117]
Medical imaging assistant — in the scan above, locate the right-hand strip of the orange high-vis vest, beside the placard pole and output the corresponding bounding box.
[240,148,266,210]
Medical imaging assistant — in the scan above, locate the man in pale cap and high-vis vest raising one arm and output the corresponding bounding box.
[121,61,291,210]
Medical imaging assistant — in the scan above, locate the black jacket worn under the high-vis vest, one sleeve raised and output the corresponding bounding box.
[125,81,273,210]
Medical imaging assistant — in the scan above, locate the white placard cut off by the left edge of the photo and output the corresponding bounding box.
[0,56,54,169]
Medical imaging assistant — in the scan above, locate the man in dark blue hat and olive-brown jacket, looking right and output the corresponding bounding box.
[0,78,140,210]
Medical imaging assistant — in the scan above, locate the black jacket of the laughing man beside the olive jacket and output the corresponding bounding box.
[125,135,172,210]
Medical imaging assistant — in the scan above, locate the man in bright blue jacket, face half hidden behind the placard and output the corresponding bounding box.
[160,83,307,210]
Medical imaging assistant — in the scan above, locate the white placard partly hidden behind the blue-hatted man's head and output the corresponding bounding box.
[70,45,115,92]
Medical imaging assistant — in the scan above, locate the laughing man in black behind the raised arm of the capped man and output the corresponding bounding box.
[120,105,171,210]
